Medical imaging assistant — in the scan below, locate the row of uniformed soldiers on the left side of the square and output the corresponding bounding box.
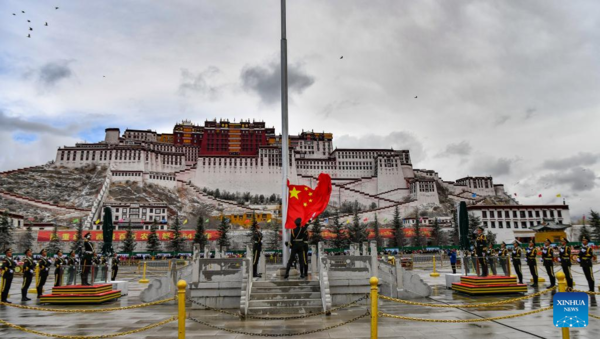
[0,233,119,303]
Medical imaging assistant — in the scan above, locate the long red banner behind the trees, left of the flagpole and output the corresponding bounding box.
[38,230,219,242]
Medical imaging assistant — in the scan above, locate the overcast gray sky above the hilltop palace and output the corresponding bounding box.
[0,0,600,217]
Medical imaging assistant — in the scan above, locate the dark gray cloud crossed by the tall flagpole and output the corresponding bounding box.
[241,61,315,104]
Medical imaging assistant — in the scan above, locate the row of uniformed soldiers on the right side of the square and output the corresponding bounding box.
[465,227,595,292]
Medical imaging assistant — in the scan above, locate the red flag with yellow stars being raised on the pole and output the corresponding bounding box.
[285,173,331,229]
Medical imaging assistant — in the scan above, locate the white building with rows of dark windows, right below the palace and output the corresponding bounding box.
[467,205,571,244]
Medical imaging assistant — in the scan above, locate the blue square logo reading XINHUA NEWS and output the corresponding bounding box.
[553,292,589,327]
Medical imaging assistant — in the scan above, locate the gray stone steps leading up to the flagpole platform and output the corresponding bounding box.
[248,280,323,314]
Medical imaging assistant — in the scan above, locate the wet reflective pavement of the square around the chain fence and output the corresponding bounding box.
[0,268,600,339]
